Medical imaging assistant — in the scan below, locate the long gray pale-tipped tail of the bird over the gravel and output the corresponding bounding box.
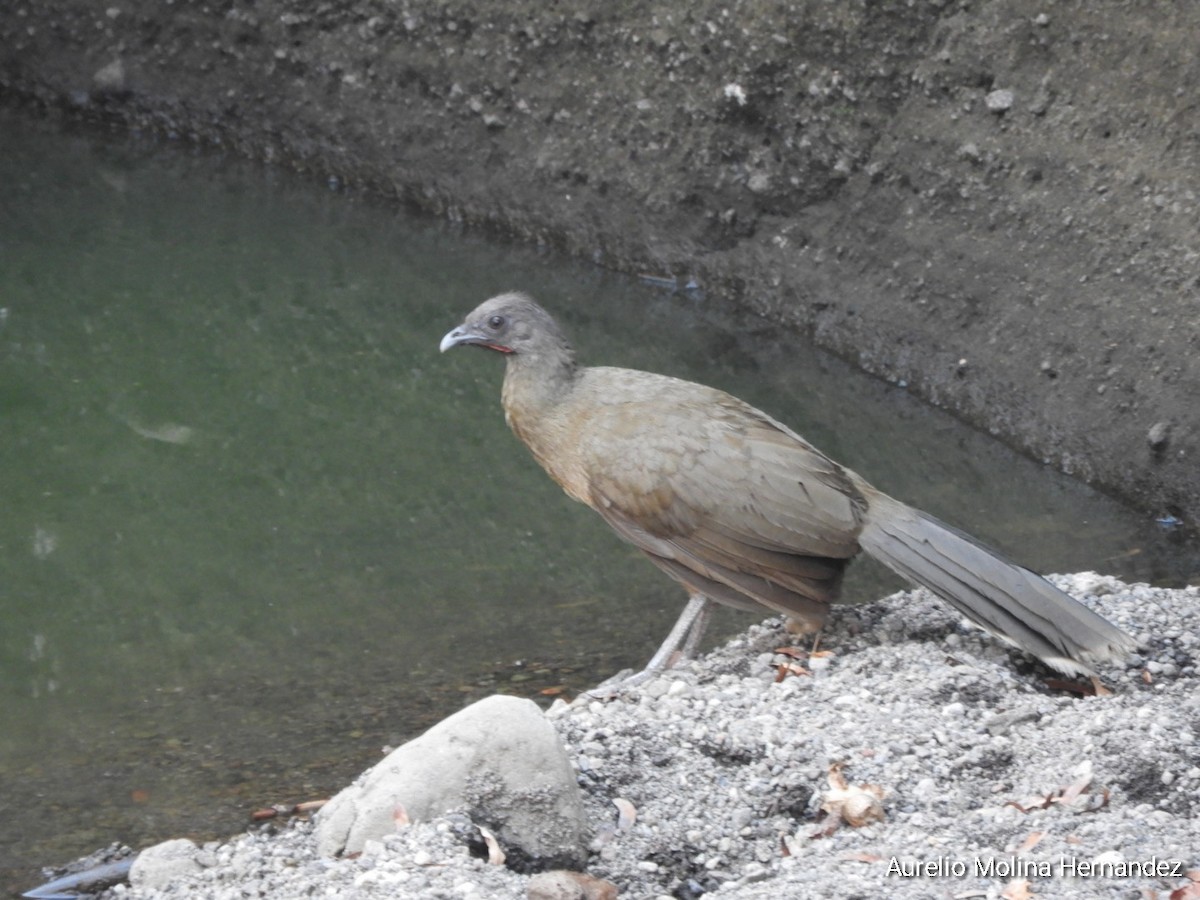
[858,490,1136,674]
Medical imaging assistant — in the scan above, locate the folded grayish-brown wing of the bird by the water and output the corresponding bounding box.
[580,385,863,608]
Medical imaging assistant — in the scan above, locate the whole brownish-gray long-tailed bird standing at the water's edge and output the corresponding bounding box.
[442,294,1134,674]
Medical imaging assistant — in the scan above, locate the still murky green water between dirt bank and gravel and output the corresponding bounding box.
[0,115,1198,888]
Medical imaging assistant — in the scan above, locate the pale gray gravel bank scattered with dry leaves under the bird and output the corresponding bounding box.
[108,574,1200,900]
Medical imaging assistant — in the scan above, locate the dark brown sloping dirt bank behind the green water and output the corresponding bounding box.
[0,0,1200,521]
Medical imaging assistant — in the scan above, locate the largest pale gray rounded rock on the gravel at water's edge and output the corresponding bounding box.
[317,695,587,865]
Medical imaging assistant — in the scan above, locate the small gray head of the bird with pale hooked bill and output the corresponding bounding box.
[440,293,575,361]
